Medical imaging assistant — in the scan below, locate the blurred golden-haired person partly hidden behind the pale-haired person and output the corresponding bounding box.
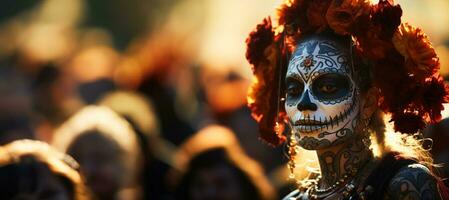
[98,91,176,200]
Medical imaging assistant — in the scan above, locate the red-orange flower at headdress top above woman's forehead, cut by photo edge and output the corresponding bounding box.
[326,0,371,35]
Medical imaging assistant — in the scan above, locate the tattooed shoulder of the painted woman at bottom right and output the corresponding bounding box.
[385,164,441,199]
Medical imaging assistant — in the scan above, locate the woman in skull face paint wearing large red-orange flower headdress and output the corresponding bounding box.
[246,0,449,200]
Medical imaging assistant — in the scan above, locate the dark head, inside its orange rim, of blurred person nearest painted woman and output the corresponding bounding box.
[178,148,262,200]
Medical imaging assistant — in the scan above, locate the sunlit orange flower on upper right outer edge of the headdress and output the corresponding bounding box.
[393,24,439,80]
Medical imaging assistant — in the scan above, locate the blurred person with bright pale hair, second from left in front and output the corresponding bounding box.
[52,106,142,200]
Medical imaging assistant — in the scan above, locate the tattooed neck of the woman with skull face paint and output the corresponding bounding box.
[317,138,373,188]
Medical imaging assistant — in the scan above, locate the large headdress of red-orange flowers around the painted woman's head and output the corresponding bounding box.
[246,0,449,145]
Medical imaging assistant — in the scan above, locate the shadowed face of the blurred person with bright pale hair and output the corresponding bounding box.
[67,133,126,199]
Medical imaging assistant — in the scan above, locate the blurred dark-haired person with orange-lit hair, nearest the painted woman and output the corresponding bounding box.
[176,125,275,200]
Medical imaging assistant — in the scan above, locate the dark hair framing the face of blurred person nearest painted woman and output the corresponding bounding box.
[175,148,262,200]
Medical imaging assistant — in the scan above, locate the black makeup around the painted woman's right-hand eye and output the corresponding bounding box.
[312,73,351,101]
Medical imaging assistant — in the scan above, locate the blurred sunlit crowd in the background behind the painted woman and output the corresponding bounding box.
[0,0,449,200]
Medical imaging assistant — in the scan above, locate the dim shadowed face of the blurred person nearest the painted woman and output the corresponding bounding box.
[189,164,245,200]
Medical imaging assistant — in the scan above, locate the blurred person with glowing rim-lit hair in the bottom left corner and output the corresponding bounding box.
[0,140,88,200]
